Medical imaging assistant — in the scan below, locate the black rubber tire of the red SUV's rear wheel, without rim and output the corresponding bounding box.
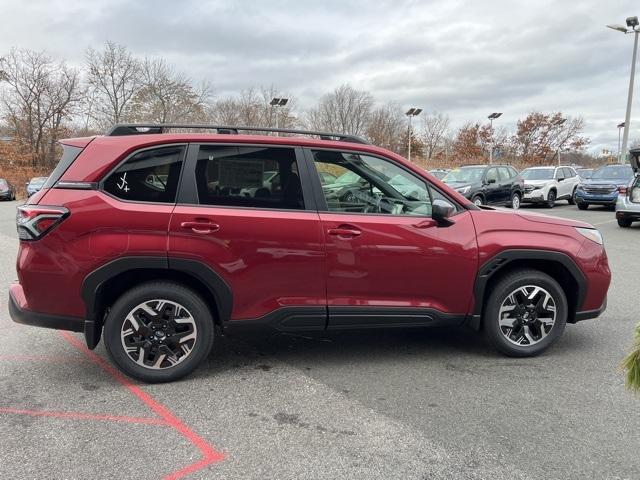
[104,281,214,383]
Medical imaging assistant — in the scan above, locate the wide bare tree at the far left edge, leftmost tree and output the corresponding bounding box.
[0,49,82,166]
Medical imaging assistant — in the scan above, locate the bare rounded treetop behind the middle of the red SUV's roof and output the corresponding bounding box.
[307,84,373,135]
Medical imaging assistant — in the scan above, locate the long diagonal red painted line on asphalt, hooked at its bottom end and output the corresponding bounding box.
[60,332,225,480]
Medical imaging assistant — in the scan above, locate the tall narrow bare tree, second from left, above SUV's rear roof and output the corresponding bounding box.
[85,41,141,127]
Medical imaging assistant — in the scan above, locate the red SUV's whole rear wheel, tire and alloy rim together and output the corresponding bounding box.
[104,282,214,383]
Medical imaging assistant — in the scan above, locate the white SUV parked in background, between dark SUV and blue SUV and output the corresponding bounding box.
[520,167,580,208]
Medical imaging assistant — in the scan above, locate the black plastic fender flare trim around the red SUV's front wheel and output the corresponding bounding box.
[467,249,587,330]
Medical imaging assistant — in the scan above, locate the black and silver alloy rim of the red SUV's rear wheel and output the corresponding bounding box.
[120,299,198,370]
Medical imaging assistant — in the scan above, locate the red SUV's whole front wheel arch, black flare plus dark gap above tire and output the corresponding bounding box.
[468,250,587,330]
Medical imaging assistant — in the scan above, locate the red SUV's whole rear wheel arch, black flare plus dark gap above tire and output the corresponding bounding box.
[82,256,233,349]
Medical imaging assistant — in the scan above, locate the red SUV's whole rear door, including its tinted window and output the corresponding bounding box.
[169,144,326,328]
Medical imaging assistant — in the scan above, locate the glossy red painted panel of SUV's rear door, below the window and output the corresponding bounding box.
[169,205,326,320]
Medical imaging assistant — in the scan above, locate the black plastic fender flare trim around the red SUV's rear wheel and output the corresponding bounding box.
[81,256,233,349]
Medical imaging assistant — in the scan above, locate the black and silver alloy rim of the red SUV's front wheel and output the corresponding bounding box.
[498,285,556,346]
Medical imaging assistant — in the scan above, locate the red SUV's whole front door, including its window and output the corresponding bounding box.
[307,150,478,328]
